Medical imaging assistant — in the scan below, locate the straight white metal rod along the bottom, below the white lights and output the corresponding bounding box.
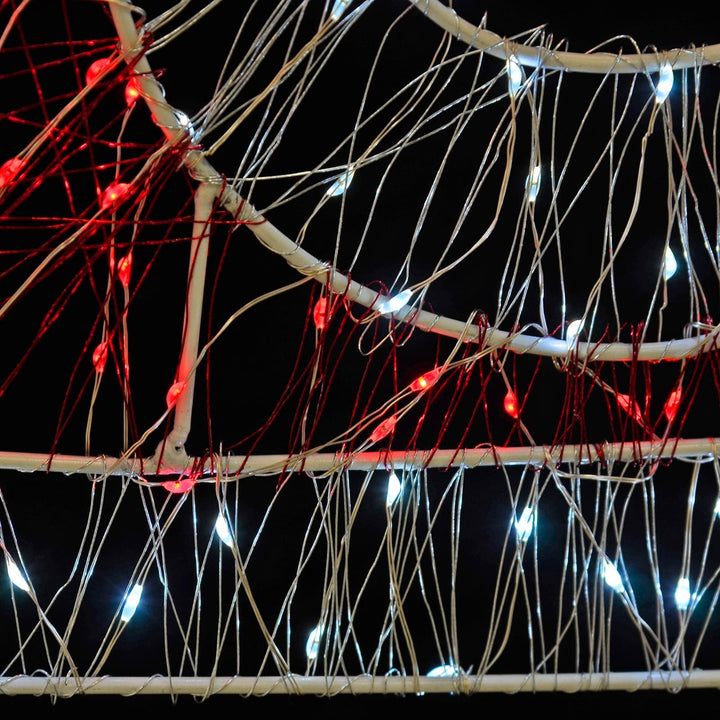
[0,670,720,697]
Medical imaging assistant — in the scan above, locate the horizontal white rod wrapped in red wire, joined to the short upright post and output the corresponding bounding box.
[0,438,720,480]
